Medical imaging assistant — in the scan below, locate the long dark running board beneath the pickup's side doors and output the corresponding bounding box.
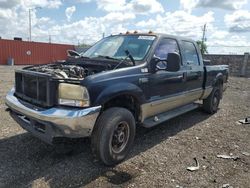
[142,103,199,128]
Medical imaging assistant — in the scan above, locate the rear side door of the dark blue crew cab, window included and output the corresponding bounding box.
[181,40,204,99]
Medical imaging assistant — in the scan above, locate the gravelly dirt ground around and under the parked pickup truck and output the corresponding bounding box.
[0,66,250,188]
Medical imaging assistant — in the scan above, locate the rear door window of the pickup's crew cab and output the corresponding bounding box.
[182,41,200,65]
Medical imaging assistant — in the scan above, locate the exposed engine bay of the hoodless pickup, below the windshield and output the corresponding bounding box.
[26,63,108,79]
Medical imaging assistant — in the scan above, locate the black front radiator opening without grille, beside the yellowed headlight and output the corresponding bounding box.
[15,71,56,107]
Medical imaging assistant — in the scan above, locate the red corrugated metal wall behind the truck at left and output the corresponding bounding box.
[0,39,74,65]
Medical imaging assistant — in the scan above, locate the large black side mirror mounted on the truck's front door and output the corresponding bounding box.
[166,53,181,72]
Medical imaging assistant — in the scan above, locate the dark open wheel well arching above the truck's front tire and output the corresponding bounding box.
[102,95,140,121]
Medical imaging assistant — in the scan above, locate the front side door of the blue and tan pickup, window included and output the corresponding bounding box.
[147,38,186,117]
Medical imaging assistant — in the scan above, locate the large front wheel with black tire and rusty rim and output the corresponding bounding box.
[91,107,135,166]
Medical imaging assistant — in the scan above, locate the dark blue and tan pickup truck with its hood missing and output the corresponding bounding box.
[6,33,228,165]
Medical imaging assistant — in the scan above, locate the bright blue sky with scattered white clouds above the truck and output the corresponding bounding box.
[0,0,250,54]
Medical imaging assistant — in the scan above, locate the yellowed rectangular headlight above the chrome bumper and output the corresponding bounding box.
[58,83,89,107]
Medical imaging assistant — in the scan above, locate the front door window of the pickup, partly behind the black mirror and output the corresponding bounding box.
[155,39,179,59]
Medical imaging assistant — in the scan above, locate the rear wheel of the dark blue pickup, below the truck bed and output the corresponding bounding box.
[203,86,221,114]
